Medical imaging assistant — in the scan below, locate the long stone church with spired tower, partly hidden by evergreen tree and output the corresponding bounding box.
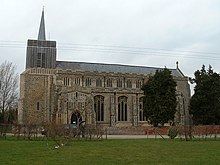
[18,11,190,127]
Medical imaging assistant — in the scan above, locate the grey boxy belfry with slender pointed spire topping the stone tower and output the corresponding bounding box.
[26,10,56,69]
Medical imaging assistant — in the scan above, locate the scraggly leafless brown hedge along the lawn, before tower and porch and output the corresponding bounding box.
[0,123,106,141]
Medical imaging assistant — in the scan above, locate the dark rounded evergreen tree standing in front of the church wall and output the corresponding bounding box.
[142,68,177,126]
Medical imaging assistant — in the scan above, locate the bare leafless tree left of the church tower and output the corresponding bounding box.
[0,61,18,123]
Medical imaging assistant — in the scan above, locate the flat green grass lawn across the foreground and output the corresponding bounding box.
[0,139,220,165]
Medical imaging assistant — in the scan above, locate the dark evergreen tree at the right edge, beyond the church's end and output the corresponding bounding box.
[189,65,220,124]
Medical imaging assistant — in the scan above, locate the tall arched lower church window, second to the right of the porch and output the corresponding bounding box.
[118,96,128,121]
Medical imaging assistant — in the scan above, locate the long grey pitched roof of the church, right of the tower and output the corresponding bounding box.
[56,61,184,77]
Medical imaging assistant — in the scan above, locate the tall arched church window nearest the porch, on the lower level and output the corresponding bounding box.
[94,95,104,121]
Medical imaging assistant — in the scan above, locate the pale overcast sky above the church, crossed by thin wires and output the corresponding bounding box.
[0,0,220,84]
